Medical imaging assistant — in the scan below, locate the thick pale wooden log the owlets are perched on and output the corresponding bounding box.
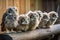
[0,24,60,40]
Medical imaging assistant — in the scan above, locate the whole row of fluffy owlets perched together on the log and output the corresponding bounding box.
[1,7,58,32]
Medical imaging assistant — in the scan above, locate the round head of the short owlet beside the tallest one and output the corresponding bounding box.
[18,14,30,25]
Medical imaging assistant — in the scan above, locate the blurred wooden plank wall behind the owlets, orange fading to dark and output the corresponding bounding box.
[0,0,60,30]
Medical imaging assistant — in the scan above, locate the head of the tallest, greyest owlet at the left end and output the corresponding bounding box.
[6,7,18,20]
